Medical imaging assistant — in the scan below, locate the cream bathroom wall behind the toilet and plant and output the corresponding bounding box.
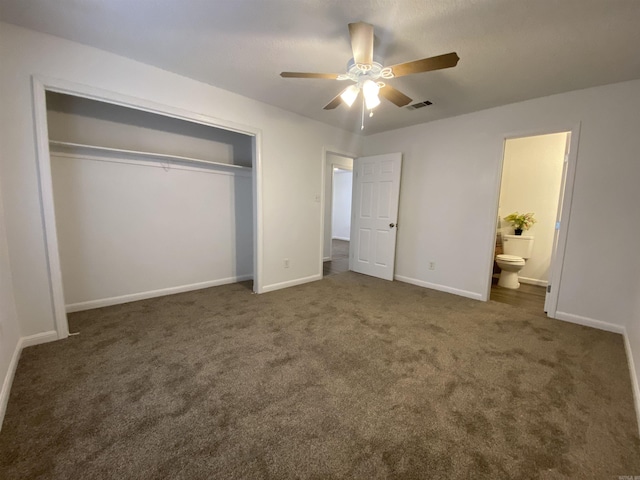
[498,133,567,285]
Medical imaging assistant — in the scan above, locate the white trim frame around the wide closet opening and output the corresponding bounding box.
[31,75,263,339]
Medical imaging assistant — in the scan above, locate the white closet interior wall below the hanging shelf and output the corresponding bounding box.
[51,148,253,311]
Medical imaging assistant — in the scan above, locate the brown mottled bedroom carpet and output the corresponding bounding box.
[0,273,640,480]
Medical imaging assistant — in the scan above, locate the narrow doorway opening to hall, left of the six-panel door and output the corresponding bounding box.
[322,152,353,276]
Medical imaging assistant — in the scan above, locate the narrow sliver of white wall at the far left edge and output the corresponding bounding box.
[0,179,20,425]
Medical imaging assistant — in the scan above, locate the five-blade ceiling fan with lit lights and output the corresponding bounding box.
[280,22,460,118]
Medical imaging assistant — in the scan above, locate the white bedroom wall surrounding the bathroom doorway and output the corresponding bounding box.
[364,81,640,331]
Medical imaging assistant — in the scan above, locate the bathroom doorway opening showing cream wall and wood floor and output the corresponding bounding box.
[489,131,572,316]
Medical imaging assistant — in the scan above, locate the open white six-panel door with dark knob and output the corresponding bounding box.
[349,153,402,280]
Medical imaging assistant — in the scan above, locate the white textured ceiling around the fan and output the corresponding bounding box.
[0,0,640,134]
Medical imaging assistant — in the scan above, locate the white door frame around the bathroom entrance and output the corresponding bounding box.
[483,122,581,318]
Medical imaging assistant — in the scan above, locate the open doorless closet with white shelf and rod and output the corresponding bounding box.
[34,78,260,338]
